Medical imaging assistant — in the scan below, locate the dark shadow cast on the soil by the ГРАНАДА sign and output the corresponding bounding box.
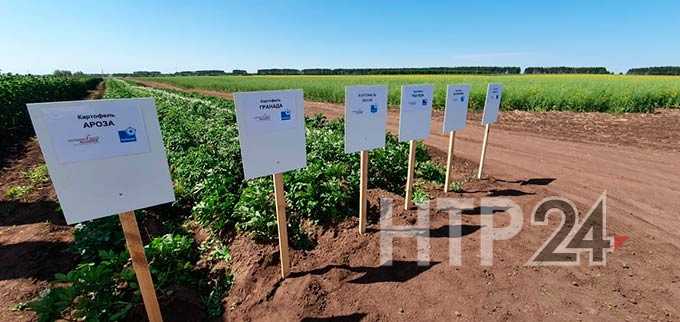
[290,261,440,284]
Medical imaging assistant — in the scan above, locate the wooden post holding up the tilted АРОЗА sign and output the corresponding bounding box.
[118,211,163,322]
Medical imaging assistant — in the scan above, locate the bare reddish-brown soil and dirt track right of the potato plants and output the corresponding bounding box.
[133,82,680,321]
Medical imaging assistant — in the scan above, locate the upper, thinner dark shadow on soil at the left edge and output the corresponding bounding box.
[0,200,66,226]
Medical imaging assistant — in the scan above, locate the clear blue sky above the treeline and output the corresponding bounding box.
[0,0,680,74]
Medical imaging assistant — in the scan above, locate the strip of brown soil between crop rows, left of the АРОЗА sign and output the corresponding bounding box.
[0,82,104,321]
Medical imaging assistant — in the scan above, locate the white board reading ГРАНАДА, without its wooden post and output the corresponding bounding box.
[234,90,307,179]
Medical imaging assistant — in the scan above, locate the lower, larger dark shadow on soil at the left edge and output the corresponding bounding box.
[0,241,75,281]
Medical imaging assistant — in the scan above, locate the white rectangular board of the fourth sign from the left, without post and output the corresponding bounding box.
[399,85,432,142]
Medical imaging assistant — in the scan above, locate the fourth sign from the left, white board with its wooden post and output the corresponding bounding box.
[399,85,433,209]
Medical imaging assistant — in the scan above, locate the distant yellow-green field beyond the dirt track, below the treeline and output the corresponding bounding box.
[138,75,680,112]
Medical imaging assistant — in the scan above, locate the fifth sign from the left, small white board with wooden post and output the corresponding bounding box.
[442,85,470,192]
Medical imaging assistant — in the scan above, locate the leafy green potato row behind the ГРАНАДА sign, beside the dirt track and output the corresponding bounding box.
[107,80,442,246]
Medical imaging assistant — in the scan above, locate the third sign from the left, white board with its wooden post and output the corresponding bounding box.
[345,85,387,234]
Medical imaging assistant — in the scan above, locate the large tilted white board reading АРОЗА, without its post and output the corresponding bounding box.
[27,98,175,224]
